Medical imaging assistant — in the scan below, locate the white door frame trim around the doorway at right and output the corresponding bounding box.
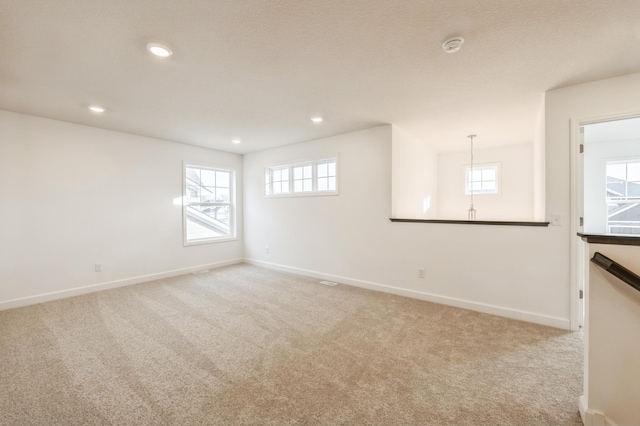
[569,109,640,331]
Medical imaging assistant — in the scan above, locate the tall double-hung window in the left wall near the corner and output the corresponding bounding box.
[183,165,235,245]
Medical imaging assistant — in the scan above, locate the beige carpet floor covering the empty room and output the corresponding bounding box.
[0,265,582,426]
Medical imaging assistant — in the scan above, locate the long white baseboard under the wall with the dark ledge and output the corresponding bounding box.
[244,258,571,330]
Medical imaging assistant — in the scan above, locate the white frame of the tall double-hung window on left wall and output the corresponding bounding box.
[182,161,238,247]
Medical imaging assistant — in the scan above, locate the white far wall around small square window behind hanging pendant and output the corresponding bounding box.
[436,144,534,221]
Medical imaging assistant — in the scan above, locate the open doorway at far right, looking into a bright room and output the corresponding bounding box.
[571,112,640,330]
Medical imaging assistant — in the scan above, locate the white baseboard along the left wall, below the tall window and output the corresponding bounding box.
[0,259,243,311]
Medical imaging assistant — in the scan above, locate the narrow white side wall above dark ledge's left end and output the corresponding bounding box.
[391,126,438,219]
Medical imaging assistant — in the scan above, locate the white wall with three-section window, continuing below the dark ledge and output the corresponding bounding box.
[244,126,569,328]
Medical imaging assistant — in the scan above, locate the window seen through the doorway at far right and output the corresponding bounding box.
[606,159,640,234]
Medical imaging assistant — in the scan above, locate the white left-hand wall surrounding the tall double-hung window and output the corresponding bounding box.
[0,111,243,308]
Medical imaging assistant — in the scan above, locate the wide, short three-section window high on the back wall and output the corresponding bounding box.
[264,158,338,197]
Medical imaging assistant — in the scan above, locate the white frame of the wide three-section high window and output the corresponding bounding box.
[263,156,339,198]
